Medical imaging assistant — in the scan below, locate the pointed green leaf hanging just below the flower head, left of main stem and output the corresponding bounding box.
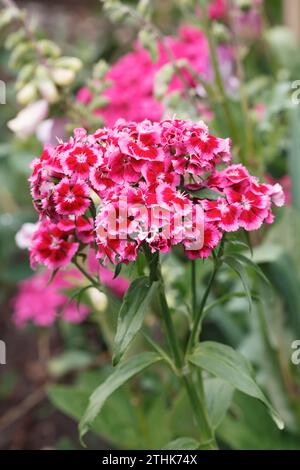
[113,276,158,365]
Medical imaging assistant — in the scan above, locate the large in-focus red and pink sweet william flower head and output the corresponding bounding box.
[30,119,284,269]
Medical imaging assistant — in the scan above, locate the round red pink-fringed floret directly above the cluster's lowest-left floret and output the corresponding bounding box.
[54,178,90,216]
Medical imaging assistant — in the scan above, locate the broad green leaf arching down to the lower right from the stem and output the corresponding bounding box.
[189,341,284,429]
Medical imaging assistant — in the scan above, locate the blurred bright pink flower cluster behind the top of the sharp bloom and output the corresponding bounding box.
[77,26,235,126]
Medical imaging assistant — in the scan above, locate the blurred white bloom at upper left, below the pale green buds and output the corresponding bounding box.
[7,100,48,139]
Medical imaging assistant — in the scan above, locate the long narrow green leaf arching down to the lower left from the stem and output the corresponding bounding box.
[79,352,161,440]
